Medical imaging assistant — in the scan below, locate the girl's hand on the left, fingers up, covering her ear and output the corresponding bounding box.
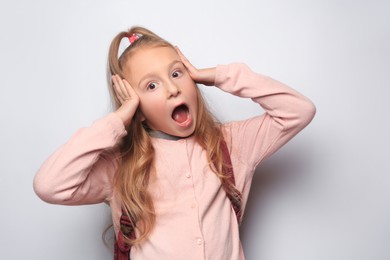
[111,75,139,126]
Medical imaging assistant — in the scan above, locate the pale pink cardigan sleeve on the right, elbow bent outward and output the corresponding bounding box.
[215,63,316,168]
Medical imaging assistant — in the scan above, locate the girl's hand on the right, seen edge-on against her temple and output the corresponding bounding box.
[175,47,215,86]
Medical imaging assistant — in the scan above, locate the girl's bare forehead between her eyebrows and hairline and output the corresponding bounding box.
[125,47,180,81]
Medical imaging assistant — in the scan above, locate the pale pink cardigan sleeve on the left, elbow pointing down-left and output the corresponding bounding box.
[33,113,126,205]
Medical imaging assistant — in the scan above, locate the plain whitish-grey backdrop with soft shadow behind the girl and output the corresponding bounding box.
[0,0,390,260]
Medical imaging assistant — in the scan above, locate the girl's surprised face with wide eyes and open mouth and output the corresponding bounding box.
[125,47,198,137]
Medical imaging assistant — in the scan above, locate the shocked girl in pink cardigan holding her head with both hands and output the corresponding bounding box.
[34,27,315,260]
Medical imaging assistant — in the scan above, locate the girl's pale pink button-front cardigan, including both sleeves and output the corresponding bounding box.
[34,64,315,260]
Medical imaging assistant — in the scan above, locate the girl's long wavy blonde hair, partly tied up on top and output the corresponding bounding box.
[108,27,238,245]
